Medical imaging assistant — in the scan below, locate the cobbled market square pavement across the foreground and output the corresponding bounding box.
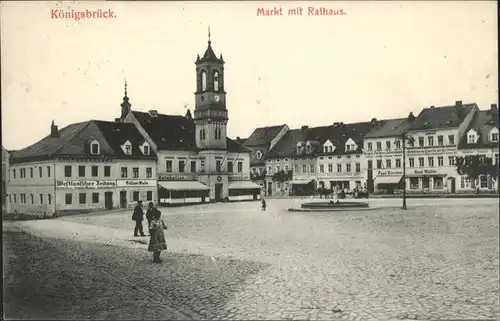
[4,199,499,320]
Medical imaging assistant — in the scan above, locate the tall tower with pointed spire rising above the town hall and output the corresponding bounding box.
[194,29,228,149]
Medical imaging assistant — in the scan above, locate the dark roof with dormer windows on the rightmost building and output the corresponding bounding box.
[458,108,499,149]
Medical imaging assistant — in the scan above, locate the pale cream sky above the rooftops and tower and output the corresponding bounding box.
[0,1,498,150]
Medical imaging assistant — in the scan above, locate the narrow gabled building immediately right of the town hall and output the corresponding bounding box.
[244,124,289,190]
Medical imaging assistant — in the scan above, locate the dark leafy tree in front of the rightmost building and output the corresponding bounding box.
[455,155,498,186]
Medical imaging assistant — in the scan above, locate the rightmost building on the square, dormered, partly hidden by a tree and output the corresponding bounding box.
[457,104,499,192]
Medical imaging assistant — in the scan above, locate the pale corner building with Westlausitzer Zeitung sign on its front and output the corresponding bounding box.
[9,120,157,215]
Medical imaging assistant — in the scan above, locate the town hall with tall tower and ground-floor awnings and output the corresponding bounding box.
[117,33,261,204]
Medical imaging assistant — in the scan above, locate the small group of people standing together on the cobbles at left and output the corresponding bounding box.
[132,201,167,263]
